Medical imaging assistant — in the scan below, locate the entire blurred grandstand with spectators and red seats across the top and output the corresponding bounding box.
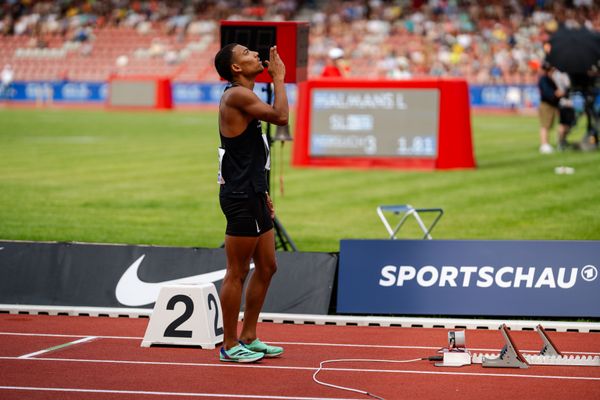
[0,0,600,84]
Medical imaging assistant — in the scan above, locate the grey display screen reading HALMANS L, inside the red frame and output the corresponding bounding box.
[309,88,439,158]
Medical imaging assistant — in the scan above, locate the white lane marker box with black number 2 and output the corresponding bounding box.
[142,283,223,349]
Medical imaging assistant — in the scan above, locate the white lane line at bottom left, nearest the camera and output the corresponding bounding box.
[0,386,356,400]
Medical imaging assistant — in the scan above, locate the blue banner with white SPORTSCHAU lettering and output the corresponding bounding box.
[337,240,600,317]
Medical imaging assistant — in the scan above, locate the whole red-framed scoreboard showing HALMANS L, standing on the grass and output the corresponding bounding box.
[293,79,475,169]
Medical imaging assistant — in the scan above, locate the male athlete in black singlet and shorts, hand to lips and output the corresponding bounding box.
[215,44,289,362]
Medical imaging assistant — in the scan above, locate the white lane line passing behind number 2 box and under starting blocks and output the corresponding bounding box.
[0,332,600,355]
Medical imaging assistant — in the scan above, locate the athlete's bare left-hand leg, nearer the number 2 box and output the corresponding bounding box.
[219,235,259,350]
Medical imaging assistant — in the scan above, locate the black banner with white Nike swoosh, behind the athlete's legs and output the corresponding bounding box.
[0,241,337,315]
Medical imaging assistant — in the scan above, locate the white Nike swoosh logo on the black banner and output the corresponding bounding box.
[115,254,254,307]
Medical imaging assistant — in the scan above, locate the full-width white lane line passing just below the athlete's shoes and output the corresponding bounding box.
[0,357,600,382]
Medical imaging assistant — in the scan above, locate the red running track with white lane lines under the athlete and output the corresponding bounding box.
[0,314,600,400]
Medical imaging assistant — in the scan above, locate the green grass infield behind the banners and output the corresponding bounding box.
[0,108,600,251]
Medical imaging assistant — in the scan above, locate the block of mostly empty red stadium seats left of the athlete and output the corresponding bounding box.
[0,22,218,81]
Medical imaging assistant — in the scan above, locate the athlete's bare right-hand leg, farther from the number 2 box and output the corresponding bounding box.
[240,229,277,343]
